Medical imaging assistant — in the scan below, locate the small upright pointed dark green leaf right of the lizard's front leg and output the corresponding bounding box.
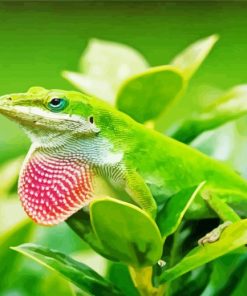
[157,182,205,238]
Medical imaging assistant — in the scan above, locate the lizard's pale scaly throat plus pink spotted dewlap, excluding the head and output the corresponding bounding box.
[19,138,123,225]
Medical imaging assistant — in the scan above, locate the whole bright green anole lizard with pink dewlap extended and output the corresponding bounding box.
[0,87,247,243]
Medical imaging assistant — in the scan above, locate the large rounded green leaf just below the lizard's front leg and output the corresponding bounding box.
[90,198,162,267]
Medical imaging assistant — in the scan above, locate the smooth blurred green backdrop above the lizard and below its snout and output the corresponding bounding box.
[0,2,247,162]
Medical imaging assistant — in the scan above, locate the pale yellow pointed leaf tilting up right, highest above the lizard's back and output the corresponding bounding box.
[171,35,218,80]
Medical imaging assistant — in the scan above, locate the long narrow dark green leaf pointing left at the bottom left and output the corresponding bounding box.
[12,244,122,296]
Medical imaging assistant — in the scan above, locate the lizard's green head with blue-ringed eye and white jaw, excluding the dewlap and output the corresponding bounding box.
[0,87,100,146]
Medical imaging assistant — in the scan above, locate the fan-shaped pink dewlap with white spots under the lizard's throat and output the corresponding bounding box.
[19,153,92,225]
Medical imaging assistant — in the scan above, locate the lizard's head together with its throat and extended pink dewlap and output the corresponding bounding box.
[0,87,106,225]
